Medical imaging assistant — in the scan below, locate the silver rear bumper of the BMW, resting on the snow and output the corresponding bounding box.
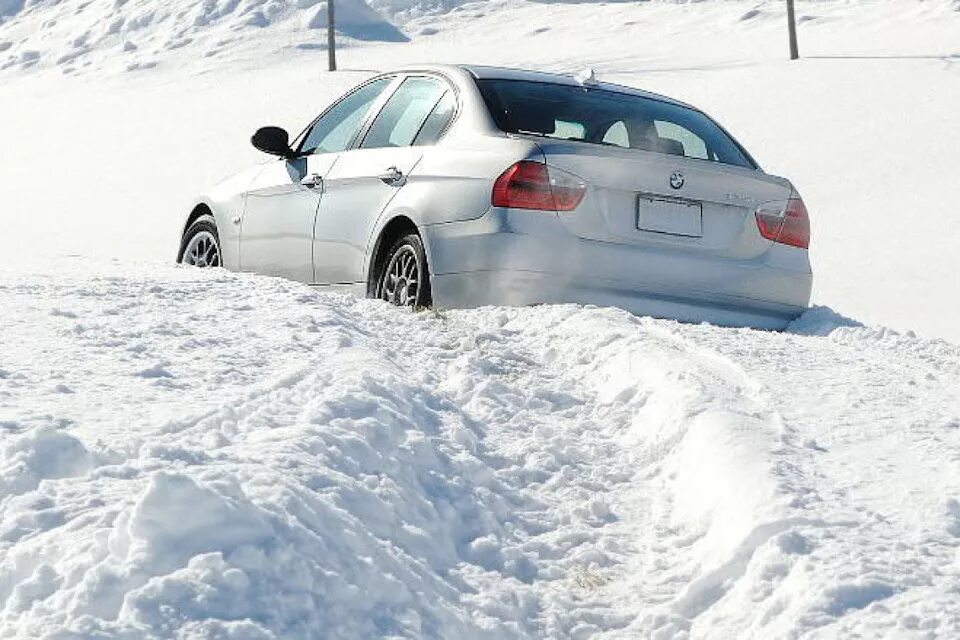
[423,209,812,329]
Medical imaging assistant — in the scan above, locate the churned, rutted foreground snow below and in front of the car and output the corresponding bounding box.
[0,259,960,638]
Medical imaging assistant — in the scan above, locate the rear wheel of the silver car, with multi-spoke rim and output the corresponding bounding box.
[376,233,433,309]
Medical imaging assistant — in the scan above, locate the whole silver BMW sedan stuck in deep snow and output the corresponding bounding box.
[178,65,812,328]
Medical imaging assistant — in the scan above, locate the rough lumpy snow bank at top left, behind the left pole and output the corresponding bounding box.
[0,0,408,73]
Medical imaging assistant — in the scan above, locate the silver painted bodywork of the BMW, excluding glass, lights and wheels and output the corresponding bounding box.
[186,65,812,328]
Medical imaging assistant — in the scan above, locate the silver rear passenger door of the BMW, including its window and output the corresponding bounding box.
[313,75,451,284]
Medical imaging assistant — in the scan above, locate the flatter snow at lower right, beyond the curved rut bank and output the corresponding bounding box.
[660,320,960,637]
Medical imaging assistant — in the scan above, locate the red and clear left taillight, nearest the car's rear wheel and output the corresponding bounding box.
[492,160,587,211]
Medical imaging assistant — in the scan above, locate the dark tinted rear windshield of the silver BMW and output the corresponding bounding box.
[477,79,756,169]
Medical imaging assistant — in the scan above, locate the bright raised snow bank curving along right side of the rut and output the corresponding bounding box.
[496,310,843,637]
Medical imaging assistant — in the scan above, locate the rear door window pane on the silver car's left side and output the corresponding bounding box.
[360,77,446,149]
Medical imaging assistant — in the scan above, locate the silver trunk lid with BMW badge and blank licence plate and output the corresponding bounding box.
[538,139,792,258]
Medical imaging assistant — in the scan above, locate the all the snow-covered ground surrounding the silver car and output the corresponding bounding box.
[0,0,960,640]
